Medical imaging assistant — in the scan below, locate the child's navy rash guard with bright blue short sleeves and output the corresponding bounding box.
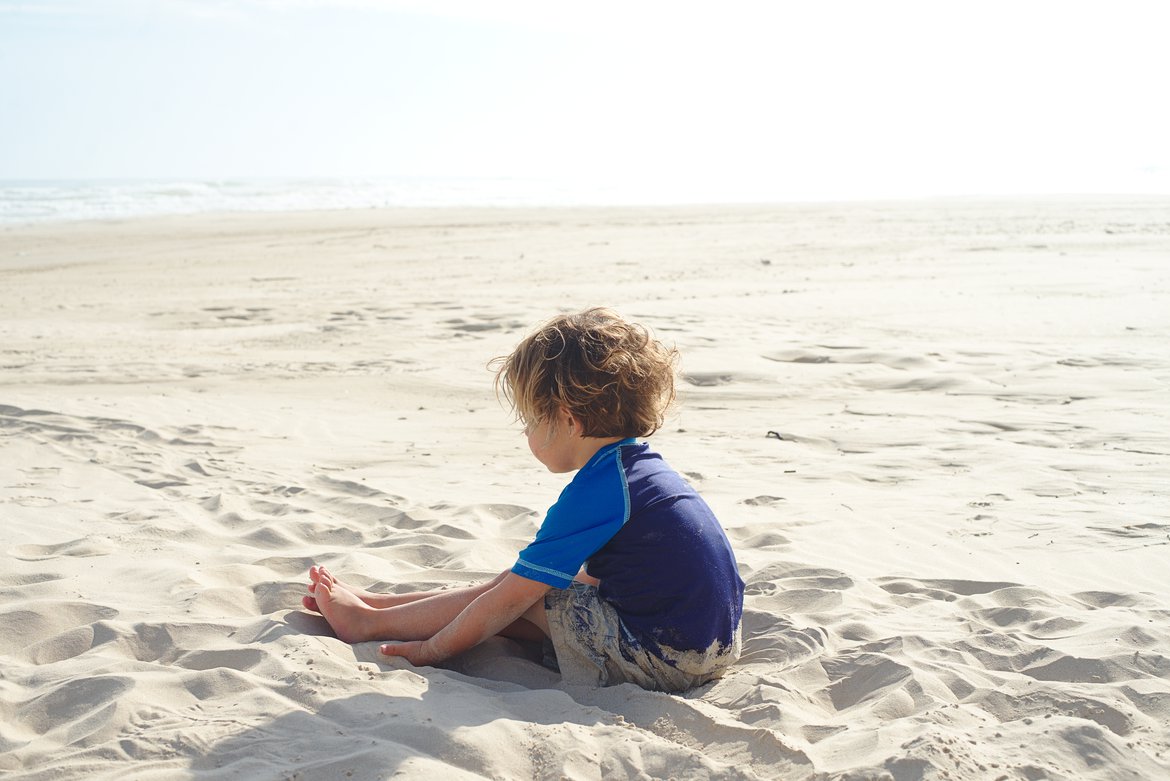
[511,440,743,659]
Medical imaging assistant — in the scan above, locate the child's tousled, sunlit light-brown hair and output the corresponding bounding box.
[496,309,679,437]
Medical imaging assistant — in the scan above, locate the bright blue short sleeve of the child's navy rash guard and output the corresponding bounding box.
[511,448,629,588]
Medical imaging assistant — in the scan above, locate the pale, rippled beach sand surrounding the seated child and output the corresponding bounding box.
[0,198,1170,781]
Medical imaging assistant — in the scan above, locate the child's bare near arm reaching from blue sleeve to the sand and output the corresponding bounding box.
[381,572,550,666]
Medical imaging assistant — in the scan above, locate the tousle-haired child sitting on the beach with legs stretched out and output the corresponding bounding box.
[304,309,743,691]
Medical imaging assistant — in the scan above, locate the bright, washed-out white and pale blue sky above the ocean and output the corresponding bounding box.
[0,0,1170,198]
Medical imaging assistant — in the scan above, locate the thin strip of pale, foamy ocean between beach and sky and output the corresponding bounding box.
[11,177,1170,224]
